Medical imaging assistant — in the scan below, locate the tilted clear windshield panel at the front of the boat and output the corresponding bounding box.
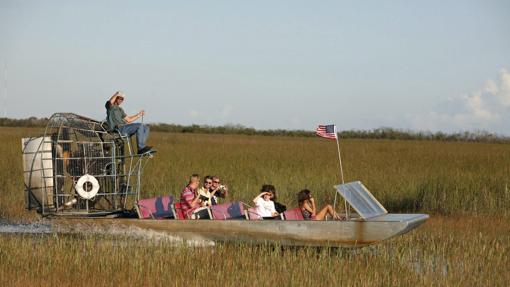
[335,181,388,219]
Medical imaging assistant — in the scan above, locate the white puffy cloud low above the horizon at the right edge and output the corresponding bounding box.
[410,69,510,134]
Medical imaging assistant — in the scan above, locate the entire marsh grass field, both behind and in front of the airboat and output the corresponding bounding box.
[0,128,510,286]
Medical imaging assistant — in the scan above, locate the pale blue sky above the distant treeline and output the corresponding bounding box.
[0,0,510,135]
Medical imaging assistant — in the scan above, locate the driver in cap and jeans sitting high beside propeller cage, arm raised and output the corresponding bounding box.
[105,91,152,154]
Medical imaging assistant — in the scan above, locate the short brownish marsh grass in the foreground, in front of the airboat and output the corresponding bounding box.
[0,217,510,286]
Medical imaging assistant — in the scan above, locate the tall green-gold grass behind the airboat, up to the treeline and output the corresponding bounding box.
[0,128,510,219]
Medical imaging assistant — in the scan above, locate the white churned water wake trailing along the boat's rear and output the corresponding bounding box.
[0,221,215,247]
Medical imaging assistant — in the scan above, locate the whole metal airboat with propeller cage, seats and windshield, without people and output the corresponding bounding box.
[22,113,429,247]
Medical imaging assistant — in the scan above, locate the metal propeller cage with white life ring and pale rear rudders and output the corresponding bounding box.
[22,113,149,216]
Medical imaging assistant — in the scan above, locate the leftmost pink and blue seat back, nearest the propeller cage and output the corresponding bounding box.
[136,195,175,219]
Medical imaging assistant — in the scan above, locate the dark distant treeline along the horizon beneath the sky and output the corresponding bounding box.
[0,117,510,143]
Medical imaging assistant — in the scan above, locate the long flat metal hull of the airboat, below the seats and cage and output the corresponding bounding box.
[54,214,429,247]
